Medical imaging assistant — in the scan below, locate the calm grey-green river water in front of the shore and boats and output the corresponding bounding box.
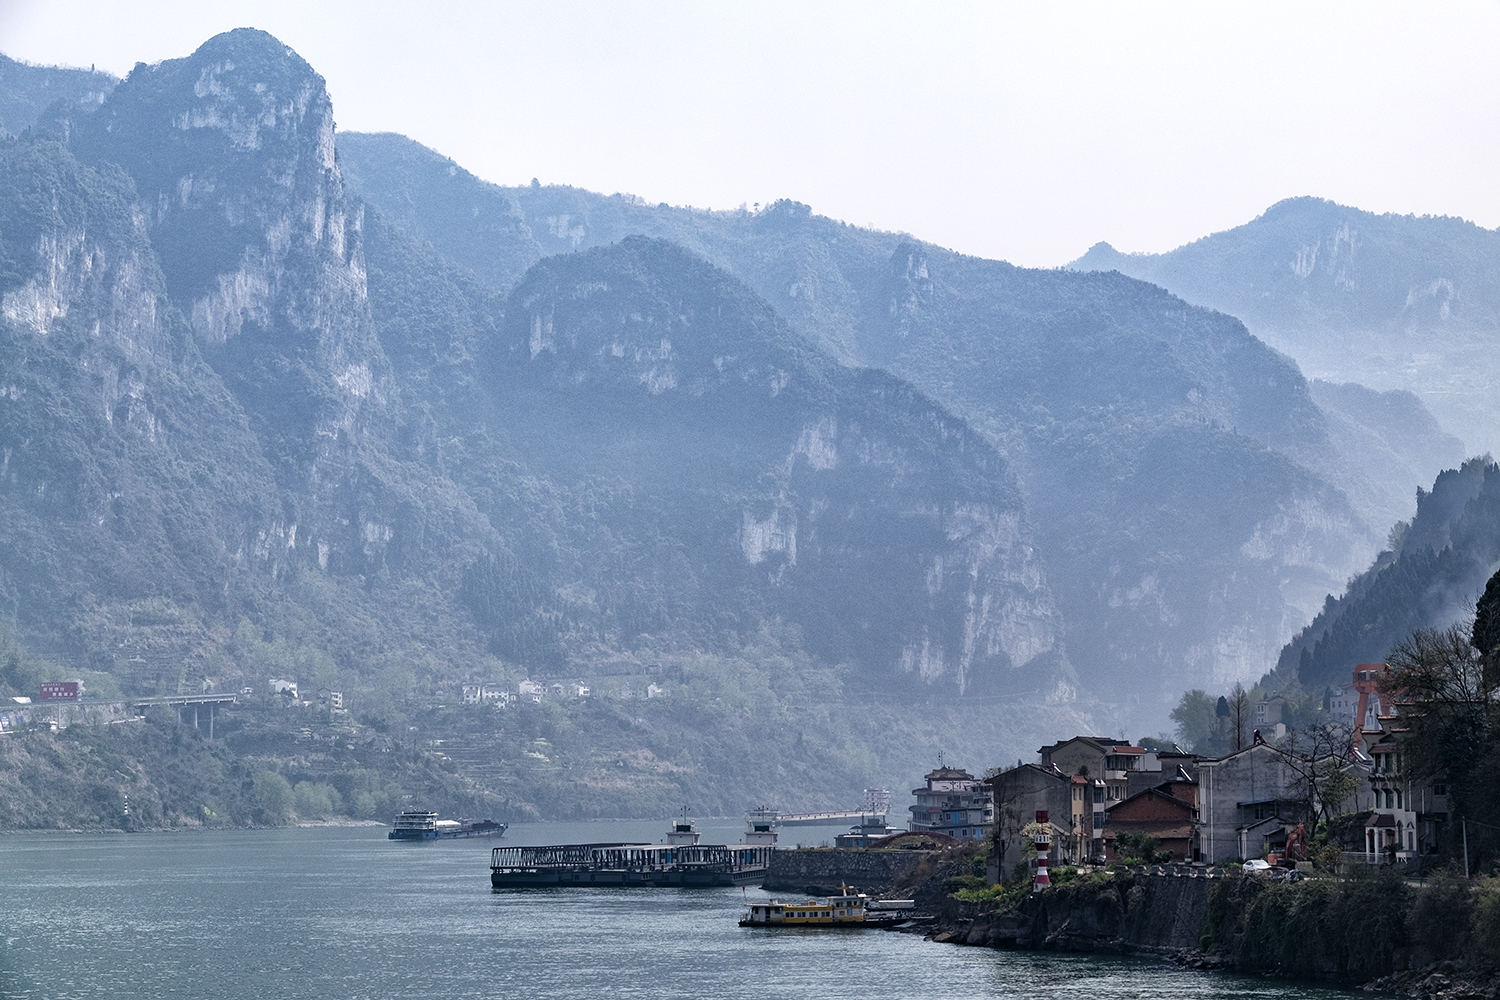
[0,822,1347,1000]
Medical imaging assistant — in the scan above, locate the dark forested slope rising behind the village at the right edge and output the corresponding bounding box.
[1277,459,1500,693]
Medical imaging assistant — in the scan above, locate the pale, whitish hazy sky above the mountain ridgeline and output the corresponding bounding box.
[0,0,1500,265]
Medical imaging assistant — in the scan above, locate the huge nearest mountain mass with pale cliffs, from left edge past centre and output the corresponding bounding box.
[0,30,1073,719]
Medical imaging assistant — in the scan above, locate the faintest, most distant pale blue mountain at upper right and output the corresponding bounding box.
[1068,198,1500,452]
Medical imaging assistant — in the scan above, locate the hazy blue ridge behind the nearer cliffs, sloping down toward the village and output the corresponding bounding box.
[339,133,1380,703]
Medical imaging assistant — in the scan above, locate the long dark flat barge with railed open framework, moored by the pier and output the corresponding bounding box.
[489,816,776,889]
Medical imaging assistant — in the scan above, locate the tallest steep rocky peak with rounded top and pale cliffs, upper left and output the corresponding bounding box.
[71,28,395,494]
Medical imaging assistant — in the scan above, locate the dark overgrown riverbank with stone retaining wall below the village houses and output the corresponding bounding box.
[900,862,1500,1000]
